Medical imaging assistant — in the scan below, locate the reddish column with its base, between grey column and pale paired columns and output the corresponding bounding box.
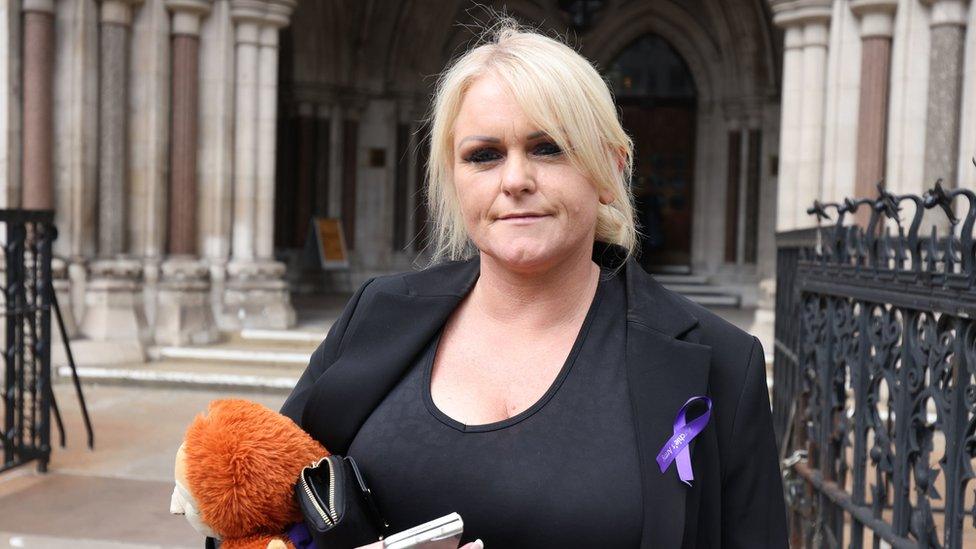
[155,0,219,345]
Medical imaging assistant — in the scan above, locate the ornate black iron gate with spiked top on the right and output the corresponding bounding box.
[773,184,976,549]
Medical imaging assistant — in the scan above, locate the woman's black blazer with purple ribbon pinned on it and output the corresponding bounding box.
[272,243,788,549]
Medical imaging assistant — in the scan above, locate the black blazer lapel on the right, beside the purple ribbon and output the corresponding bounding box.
[627,255,711,548]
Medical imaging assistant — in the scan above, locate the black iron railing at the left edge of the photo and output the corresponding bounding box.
[0,210,94,472]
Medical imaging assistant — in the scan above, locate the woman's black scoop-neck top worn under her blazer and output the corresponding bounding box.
[348,270,642,548]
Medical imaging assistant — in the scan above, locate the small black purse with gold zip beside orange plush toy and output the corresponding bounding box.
[295,456,388,549]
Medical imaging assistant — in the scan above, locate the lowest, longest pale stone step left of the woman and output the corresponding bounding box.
[55,360,305,394]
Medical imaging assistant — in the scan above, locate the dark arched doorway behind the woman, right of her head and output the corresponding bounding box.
[605,34,698,270]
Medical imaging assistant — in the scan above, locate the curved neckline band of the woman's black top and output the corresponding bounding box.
[420,268,607,433]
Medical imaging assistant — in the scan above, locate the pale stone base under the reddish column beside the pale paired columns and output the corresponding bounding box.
[155,257,220,345]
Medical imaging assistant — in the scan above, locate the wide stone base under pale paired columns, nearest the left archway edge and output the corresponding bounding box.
[220,260,295,330]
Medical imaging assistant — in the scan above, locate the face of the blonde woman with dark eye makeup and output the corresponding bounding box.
[454,74,610,272]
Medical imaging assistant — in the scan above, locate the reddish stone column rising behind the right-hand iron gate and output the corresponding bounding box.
[850,0,898,214]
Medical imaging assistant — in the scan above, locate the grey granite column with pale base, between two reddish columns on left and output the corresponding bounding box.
[81,0,149,361]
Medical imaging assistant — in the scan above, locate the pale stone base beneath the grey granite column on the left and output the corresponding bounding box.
[81,258,150,360]
